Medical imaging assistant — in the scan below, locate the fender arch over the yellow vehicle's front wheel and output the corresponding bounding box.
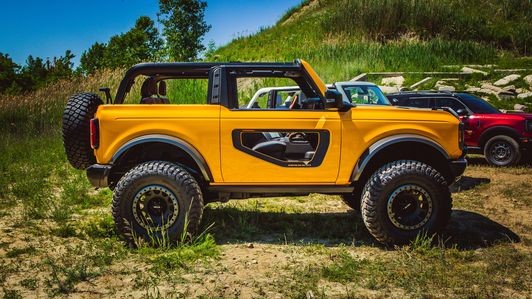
[351,134,454,187]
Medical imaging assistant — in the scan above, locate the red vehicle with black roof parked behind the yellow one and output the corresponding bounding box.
[387,91,532,166]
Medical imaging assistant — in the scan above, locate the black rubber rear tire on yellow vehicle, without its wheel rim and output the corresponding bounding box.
[112,161,203,247]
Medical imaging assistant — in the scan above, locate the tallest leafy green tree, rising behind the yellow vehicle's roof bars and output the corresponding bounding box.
[157,0,211,61]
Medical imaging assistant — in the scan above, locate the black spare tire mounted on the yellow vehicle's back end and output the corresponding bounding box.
[63,93,103,169]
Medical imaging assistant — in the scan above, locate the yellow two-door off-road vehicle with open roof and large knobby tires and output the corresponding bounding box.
[63,60,466,244]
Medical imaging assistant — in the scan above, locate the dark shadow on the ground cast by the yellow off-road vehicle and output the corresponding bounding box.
[203,206,520,249]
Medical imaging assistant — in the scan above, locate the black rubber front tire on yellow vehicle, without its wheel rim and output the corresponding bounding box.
[361,160,452,245]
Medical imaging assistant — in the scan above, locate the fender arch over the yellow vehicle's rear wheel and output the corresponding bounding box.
[111,134,212,183]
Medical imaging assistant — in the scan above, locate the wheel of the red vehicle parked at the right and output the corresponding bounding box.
[484,135,521,167]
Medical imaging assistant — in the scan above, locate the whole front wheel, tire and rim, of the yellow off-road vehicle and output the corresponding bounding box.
[361,160,452,245]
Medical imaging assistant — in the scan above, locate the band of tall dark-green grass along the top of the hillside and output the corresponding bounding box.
[321,0,532,55]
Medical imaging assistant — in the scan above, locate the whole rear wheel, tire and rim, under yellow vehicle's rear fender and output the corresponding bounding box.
[112,161,203,246]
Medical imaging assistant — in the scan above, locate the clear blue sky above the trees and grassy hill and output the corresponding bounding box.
[0,0,301,64]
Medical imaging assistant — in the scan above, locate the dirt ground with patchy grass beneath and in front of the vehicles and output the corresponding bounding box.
[0,157,532,298]
